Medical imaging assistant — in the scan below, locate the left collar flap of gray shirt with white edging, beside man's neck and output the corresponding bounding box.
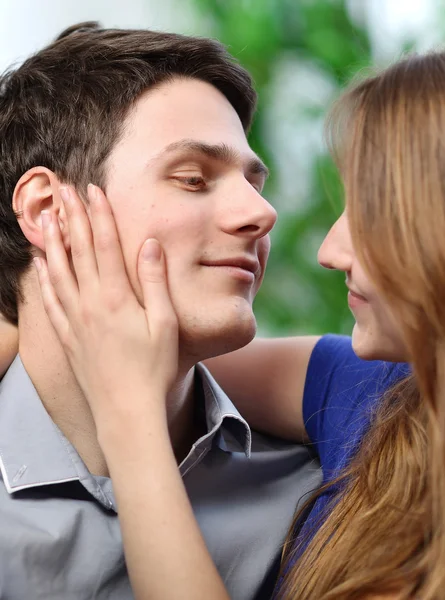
[0,356,81,494]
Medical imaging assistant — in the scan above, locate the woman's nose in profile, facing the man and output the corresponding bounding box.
[318,213,353,271]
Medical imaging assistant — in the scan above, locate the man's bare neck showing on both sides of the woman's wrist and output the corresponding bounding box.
[19,294,198,476]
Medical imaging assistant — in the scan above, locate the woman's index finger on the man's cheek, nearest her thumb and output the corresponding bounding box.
[88,183,131,296]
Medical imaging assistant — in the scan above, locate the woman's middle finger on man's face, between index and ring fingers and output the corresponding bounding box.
[60,186,98,291]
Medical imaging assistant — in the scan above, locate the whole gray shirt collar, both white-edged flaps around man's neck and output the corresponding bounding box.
[0,356,251,494]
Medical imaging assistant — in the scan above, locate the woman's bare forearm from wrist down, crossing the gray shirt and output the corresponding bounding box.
[99,406,229,600]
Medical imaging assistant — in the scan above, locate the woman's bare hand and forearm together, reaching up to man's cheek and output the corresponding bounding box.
[36,186,229,600]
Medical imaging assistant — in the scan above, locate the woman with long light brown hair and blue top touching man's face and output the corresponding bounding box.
[1,53,445,600]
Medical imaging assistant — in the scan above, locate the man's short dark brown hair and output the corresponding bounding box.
[0,23,256,323]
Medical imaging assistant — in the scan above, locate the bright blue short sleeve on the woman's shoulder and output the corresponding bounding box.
[303,335,409,479]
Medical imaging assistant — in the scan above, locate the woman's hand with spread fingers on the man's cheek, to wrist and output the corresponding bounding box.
[35,184,178,431]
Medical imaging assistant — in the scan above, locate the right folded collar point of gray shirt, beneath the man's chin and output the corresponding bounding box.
[196,364,252,458]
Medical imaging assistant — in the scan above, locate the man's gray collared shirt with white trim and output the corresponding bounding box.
[0,357,321,600]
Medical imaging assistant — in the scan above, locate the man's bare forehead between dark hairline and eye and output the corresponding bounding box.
[114,80,267,174]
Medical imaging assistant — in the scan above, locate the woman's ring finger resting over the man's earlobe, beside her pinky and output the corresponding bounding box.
[42,210,79,312]
